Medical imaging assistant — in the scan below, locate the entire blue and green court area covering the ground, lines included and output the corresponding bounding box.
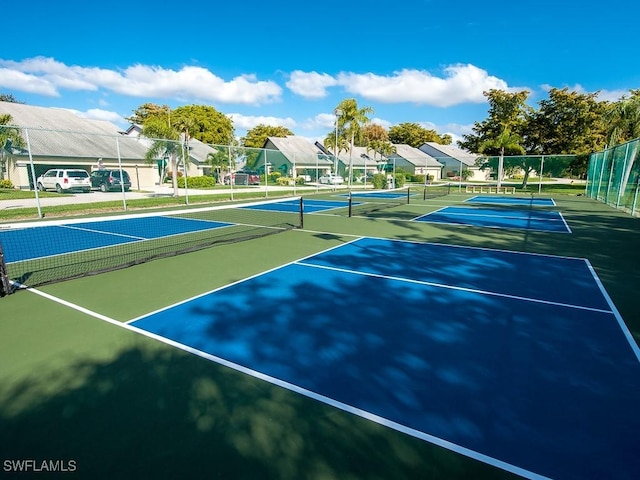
[0,189,640,480]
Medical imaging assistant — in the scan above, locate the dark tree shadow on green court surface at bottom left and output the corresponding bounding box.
[0,339,512,479]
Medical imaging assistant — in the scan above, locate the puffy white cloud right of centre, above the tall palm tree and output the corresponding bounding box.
[338,65,508,107]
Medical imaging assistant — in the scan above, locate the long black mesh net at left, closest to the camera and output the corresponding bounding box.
[0,197,303,287]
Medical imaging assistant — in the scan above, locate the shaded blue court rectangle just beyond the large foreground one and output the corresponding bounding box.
[413,207,571,233]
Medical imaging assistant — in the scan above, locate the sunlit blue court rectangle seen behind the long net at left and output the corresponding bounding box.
[0,216,231,263]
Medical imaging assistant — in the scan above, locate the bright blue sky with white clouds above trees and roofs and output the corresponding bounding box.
[0,0,640,145]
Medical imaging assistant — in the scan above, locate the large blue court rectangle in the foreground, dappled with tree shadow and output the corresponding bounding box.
[129,238,640,480]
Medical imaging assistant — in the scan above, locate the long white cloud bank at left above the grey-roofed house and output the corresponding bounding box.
[0,57,282,105]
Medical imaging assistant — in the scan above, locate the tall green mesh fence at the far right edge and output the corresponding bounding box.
[586,138,640,216]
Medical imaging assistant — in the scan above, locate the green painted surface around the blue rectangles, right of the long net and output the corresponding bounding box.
[0,189,640,479]
